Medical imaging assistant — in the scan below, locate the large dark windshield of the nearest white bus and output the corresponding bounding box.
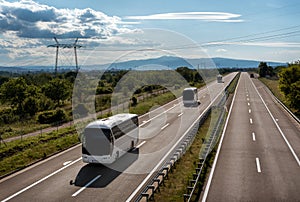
[84,128,113,156]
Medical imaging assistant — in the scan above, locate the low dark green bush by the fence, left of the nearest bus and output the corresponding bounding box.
[38,109,68,124]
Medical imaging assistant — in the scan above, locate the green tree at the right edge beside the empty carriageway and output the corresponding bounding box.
[279,64,300,111]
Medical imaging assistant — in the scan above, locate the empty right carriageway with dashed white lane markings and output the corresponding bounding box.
[202,73,300,201]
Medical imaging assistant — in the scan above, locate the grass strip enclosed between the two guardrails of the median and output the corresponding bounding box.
[155,113,211,202]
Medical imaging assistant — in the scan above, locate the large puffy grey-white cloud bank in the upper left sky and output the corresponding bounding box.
[0,0,135,38]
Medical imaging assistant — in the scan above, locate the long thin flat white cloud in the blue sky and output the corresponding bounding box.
[125,12,243,22]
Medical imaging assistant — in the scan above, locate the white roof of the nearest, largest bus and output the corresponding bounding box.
[86,113,137,128]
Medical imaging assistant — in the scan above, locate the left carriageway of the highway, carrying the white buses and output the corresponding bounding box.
[0,73,236,201]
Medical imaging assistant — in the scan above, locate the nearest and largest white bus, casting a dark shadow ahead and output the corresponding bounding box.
[82,113,139,164]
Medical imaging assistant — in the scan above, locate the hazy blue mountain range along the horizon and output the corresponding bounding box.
[0,56,287,72]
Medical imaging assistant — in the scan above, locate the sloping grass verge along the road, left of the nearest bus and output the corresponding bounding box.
[0,128,79,176]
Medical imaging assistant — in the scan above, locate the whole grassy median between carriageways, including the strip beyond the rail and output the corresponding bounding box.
[154,72,239,201]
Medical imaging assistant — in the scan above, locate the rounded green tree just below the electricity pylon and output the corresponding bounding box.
[42,78,71,106]
